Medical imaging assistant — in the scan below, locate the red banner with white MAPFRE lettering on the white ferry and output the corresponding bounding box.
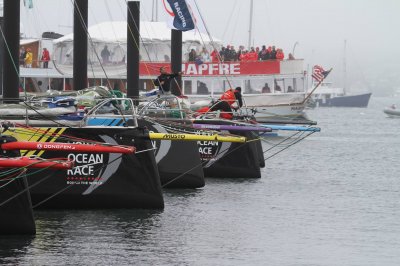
[139,61,280,76]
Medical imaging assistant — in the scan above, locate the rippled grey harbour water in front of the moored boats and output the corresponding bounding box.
[0,98,400,266]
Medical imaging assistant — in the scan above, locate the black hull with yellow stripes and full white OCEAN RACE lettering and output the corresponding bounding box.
[4,128,164,209]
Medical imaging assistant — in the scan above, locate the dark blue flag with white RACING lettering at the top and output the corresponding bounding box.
[168,0,194,31]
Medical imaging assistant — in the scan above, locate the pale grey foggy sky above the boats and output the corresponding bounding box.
[17,0,400,95]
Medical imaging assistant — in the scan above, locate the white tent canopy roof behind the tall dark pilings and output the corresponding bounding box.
[53,21,221,44]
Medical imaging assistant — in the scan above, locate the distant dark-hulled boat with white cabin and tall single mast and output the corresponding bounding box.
[312,41,372,107]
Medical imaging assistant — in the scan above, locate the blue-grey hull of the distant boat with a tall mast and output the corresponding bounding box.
[316,93,372,107]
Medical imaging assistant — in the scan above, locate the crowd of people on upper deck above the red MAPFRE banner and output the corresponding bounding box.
[188,45,294,64]
